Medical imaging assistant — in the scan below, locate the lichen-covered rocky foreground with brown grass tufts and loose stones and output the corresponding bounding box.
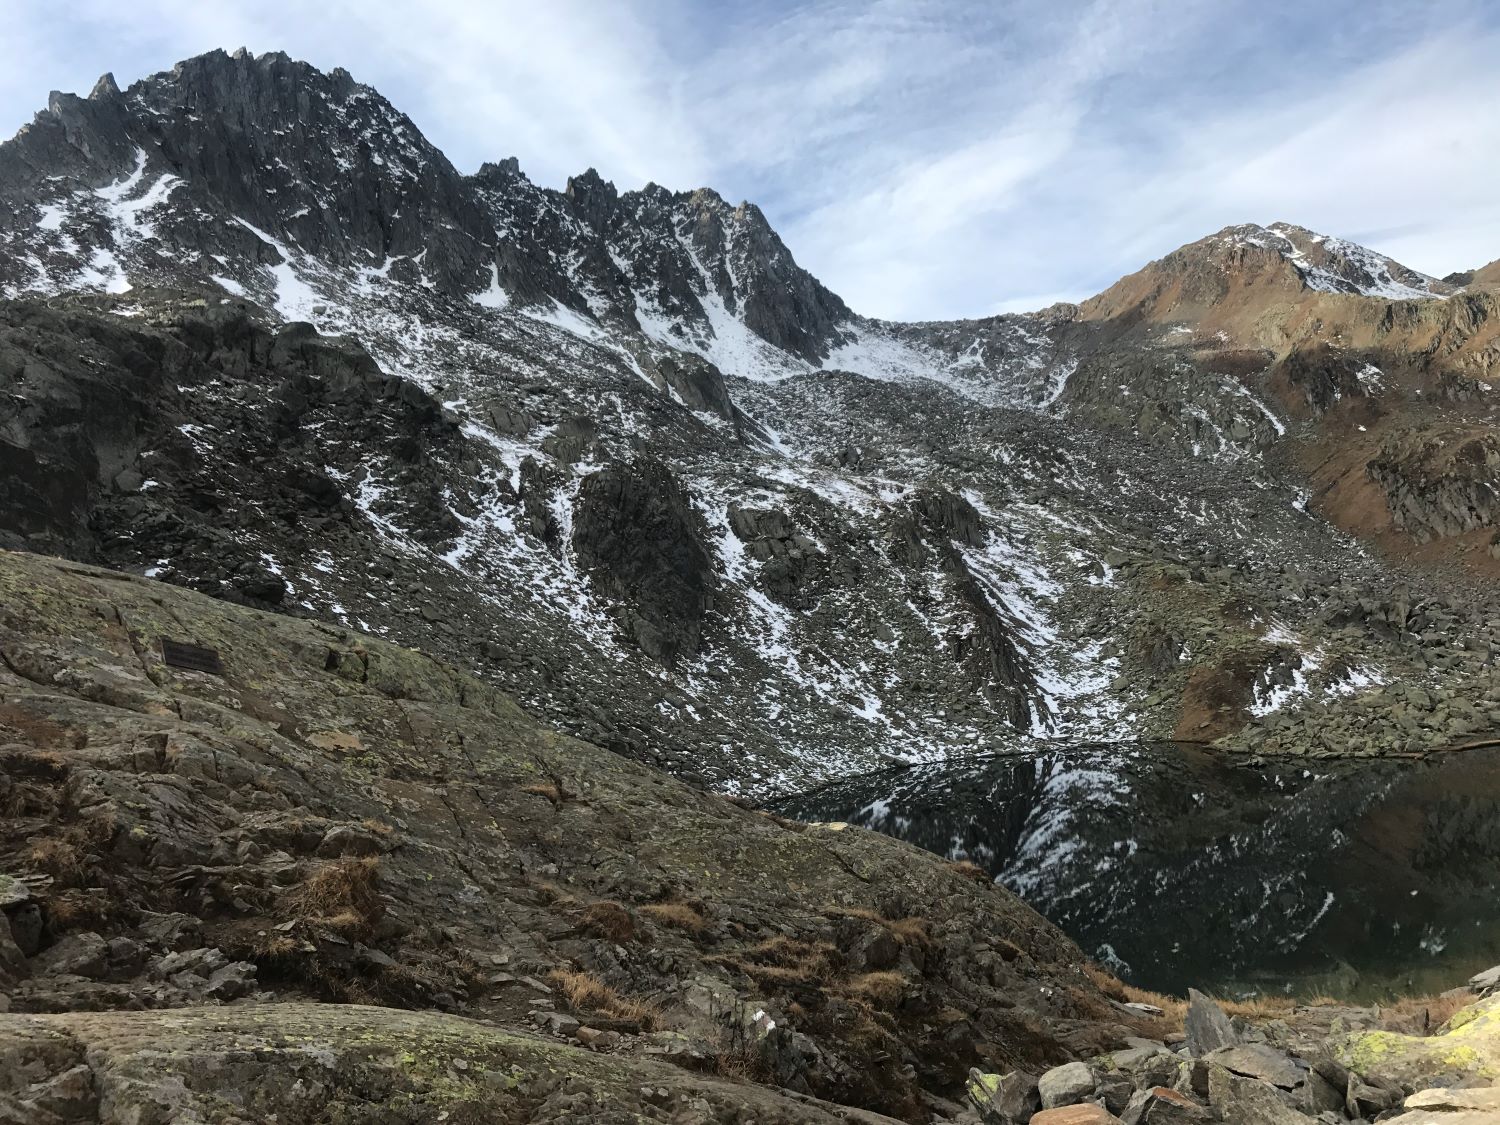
[0,552,1500,1125]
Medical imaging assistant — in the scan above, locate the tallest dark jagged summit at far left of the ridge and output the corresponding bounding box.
[0,50,494,297]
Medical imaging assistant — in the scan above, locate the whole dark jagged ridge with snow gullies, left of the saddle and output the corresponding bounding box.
[0,50,855,375]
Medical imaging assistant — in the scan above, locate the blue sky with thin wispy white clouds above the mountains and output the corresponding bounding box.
[0,0,1500,320]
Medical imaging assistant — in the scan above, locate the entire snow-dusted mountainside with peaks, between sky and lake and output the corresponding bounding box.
[0,44,1500,794]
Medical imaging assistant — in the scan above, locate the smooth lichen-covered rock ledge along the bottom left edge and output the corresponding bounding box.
[0,1004,893,1125]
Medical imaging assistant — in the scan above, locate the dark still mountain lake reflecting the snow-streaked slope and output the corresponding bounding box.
[770,743,1500,1001]
